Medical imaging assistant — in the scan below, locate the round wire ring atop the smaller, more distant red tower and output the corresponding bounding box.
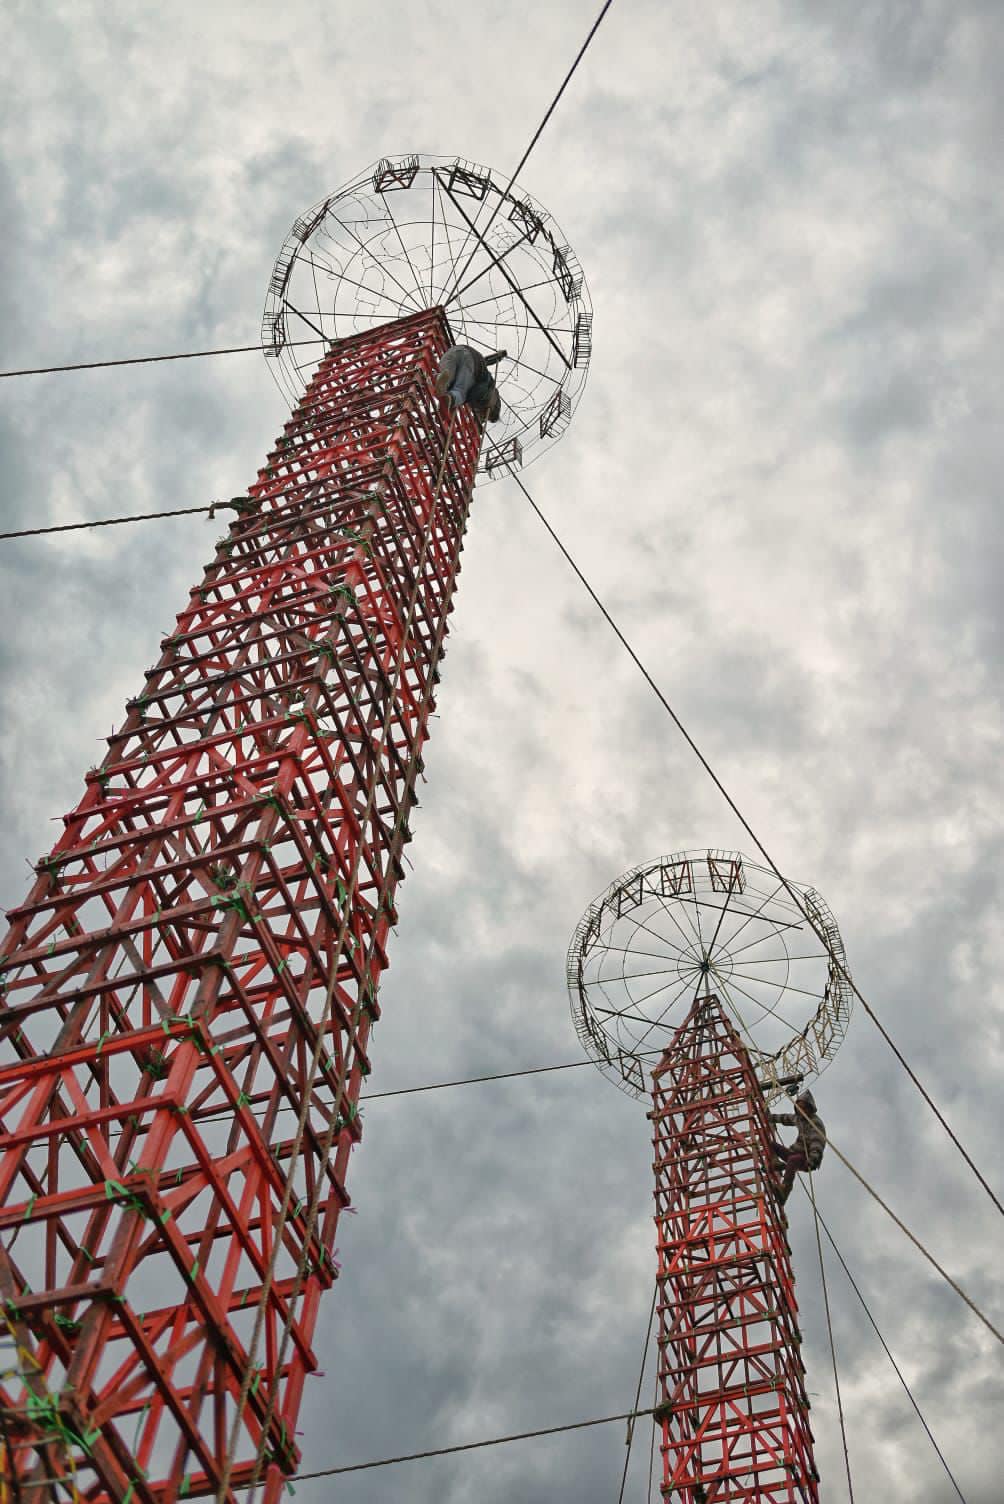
[567,850,852,1096]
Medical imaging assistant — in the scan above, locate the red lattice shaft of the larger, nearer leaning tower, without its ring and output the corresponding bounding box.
[0,299,481,1504]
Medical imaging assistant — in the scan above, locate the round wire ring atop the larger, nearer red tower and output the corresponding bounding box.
[262,146,592,475]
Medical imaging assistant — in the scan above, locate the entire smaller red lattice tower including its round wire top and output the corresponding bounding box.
[568,850,851,1504]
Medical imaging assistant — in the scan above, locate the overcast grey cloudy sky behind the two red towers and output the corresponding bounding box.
[0,0,1004,1504]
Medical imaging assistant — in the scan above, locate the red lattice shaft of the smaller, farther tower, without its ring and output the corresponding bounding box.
[649,994,819,1504]
